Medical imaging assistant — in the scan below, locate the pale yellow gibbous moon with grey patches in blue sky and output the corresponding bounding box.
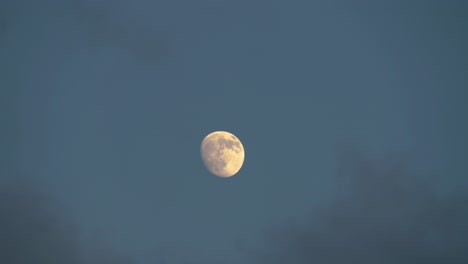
[201,131,245,178]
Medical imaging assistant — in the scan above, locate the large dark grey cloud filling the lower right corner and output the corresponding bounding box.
[252,146,468,264]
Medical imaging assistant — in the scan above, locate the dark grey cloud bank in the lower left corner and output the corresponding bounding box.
[0,177,134,264]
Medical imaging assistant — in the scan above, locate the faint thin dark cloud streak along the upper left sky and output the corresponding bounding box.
[4,0,173,65]
